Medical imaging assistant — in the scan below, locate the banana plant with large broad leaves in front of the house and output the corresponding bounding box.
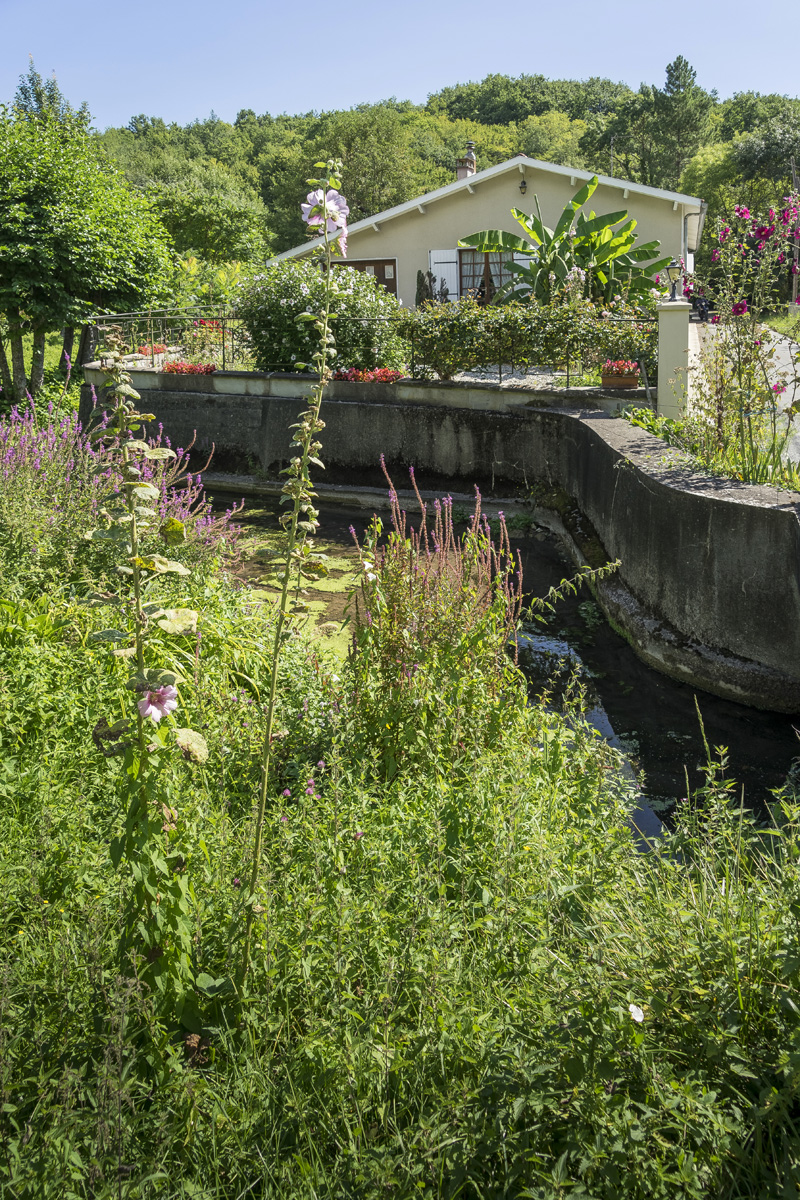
[458,175,669,304]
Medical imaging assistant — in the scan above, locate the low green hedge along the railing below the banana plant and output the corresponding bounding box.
[397,298,657,379]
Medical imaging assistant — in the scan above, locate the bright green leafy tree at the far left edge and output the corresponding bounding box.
[0,107,169,400]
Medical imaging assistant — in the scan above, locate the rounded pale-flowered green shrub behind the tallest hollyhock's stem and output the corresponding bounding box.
[236,262,404,371]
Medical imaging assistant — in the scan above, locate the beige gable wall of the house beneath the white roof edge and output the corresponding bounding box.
[328,167,697,306]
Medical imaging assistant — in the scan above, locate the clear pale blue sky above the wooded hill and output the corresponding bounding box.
[0,0,800,128]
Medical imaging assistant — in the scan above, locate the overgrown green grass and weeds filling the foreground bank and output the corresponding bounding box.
[0,400,800,1200]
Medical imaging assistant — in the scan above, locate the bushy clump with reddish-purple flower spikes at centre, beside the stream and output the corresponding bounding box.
[343,468,524,780]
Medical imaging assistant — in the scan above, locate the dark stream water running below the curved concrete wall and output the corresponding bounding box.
[219,496,800,822]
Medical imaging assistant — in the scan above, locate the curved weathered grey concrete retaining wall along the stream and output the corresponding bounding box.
[82,368,800,712]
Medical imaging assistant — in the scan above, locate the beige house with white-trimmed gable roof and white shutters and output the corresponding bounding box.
[273,143,706,305]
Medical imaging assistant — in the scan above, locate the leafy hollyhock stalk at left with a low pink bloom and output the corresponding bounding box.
[85,326,207,1020]
